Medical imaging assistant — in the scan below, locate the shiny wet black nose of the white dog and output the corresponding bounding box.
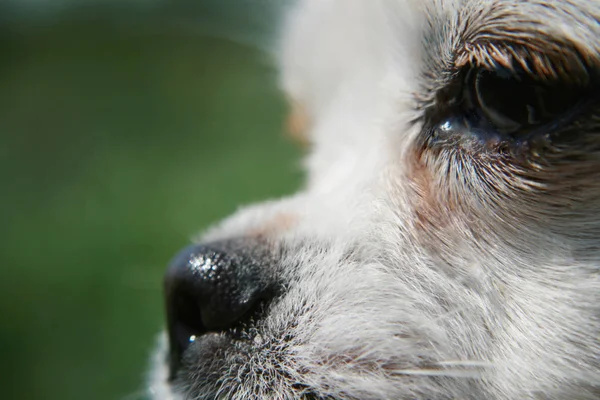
[164,241,273,377]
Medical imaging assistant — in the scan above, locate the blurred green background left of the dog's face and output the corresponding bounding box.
[0,0,301,400]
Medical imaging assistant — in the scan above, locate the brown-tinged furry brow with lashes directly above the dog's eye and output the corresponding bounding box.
[410,0,600,102]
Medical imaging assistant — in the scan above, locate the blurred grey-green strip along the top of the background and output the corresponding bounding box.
[0,0,295,49]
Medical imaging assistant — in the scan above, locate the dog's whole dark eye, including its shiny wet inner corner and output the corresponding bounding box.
[437,64,589,142]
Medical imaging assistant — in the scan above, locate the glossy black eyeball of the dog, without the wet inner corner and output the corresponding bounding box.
[467,69,582,134]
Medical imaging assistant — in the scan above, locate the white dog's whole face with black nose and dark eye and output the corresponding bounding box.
[151,0,600,400]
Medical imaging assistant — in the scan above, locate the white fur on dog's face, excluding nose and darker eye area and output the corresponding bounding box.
[151,0,600,400]
